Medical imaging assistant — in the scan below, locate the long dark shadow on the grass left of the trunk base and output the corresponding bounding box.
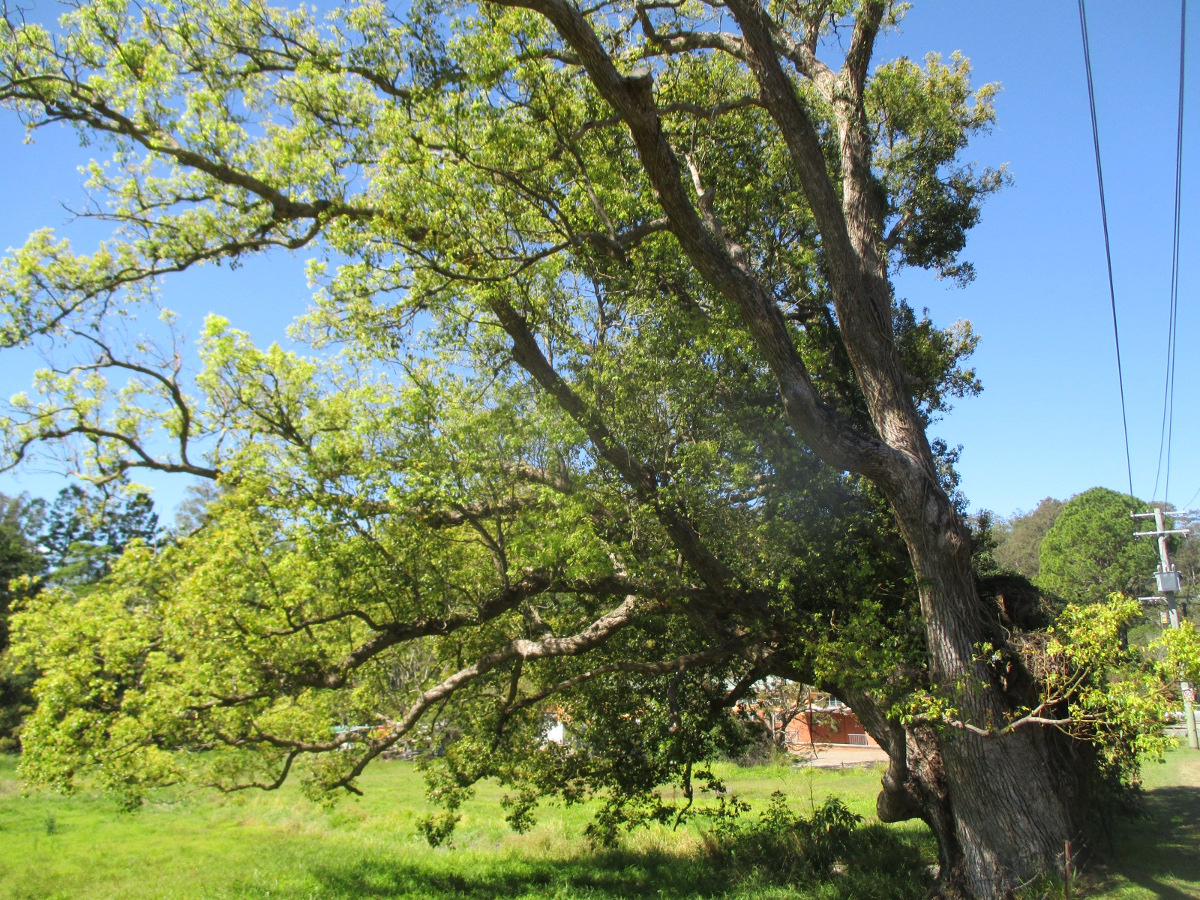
[302,829,931,900]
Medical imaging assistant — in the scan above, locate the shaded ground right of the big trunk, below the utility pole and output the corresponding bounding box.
[1096,787,1200,900]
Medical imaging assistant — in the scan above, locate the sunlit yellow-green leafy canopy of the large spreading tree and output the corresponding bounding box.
[0,0,1001,804]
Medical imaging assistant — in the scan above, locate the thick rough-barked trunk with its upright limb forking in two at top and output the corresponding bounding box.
[715,26,1094,898]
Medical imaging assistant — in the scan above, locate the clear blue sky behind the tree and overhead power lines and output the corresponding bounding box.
[0,0,1200,515]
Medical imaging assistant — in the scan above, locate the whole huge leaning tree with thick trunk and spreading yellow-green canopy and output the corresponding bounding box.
[0,0,1161,898]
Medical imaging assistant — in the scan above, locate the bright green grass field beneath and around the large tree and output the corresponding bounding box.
[0,751,1200,900]
